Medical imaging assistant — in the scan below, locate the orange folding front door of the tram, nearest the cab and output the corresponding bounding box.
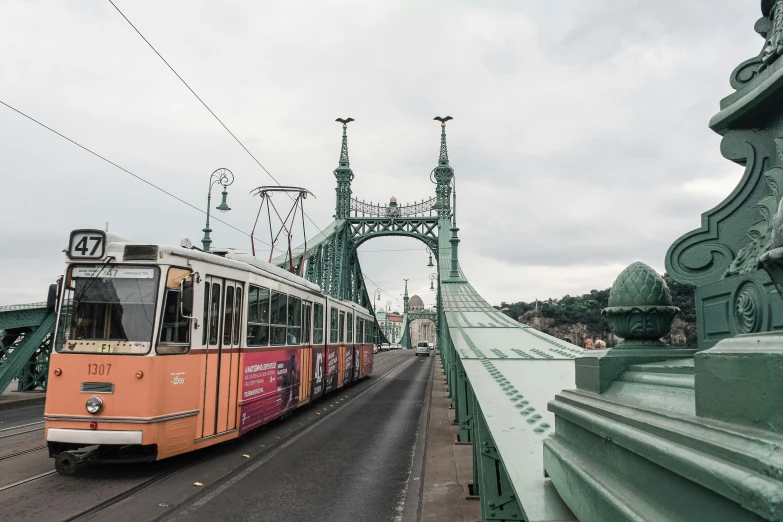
[201,276,243,437]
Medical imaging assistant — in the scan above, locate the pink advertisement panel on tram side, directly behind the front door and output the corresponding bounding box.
[239,348,301,435]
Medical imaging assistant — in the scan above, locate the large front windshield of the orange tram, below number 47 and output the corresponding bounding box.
[55,265,159,354]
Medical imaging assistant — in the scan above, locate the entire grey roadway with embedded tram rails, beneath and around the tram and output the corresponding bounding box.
[0,351,432,522]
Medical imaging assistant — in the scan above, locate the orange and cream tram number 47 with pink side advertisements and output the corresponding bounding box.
[44,230,378,475]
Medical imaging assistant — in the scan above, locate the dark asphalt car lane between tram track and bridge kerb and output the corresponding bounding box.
[168,352,432,522]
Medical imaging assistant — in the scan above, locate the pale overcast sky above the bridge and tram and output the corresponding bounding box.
[0,0,763,308]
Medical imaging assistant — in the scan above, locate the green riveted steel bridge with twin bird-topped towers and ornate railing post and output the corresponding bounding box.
[7,0,783,522]
